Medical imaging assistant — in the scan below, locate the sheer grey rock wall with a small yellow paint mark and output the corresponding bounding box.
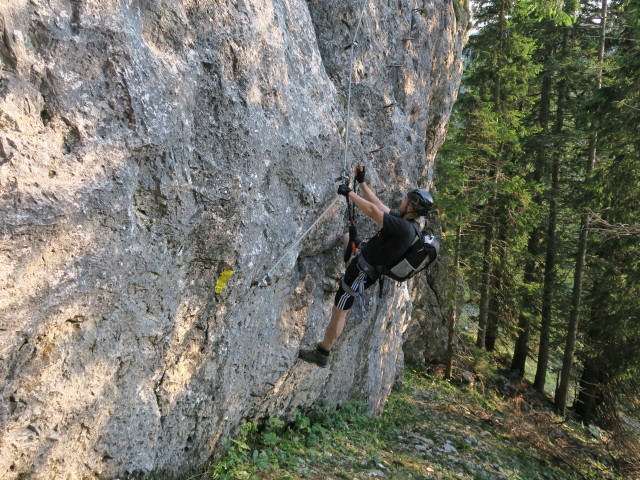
[0,0,467,479]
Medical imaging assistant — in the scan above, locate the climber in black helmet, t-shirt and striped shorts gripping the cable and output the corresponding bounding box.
[299,165,433,368]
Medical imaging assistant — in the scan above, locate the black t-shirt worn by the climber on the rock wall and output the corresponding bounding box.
[362,211,416,266]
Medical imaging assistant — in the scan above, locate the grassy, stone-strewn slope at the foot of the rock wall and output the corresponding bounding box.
[192,360,636,480]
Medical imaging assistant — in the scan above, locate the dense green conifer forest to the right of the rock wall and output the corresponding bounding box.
[436,0,640,428]
